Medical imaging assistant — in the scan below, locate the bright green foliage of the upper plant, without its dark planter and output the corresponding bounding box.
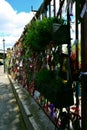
[25,18,64,51]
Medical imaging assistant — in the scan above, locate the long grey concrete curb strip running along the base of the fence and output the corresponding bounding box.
[8,75,58,130]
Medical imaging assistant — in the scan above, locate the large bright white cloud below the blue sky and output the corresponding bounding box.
[0,0,34,49]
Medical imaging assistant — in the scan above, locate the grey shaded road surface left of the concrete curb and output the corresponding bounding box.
[0,66,26,130]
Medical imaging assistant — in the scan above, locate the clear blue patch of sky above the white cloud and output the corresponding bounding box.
[6,0,43,12]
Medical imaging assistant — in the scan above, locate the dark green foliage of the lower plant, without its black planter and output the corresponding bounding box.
[35,69,63,102]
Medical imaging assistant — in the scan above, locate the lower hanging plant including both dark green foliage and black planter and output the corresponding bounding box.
[35,69,73,108]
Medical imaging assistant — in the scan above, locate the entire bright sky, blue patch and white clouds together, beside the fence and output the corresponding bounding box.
[0,0,43,51]
